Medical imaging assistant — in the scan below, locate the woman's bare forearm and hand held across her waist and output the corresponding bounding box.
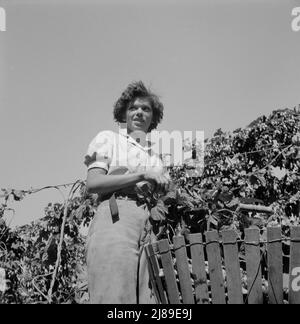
[86,168,169,194]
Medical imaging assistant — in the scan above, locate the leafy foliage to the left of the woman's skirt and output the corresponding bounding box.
[0,185,95,303]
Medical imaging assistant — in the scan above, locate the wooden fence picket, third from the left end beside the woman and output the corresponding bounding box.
[173,236,195,304]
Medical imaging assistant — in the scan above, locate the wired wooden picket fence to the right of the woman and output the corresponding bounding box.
[145,226,300,304]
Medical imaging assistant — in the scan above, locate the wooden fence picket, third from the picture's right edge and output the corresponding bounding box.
[245,228,263,304]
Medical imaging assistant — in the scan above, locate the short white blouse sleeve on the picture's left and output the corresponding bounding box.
[84,131,114,171]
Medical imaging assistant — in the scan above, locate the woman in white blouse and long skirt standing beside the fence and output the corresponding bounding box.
[85,82,169,304]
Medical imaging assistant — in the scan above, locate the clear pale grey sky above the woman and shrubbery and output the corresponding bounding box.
[0,0,300,225]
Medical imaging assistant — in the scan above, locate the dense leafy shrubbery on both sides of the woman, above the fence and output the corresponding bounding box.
[0,109,300,303]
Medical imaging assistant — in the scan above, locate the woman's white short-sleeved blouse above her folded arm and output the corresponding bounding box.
[84,131,165,174]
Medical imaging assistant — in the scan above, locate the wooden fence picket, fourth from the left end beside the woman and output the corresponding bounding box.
[189,233,209,304]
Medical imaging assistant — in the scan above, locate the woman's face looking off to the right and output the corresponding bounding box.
[126,98,153,134]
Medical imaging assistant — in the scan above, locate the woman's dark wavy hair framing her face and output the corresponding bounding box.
[113,81,164,132]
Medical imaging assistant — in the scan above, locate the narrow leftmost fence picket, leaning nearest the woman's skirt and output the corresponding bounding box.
[146,243,168,304]
